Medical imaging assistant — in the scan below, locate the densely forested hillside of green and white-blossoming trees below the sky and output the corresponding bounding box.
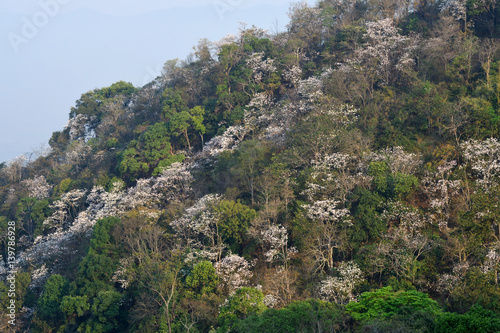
[0,0,500,333]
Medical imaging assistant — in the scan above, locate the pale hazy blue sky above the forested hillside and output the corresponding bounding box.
[0,0,313,162]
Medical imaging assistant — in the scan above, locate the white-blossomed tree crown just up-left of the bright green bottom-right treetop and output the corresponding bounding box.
[319,261,363,304]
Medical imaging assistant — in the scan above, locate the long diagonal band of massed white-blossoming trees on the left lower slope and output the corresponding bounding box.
[25,164,192,262]
